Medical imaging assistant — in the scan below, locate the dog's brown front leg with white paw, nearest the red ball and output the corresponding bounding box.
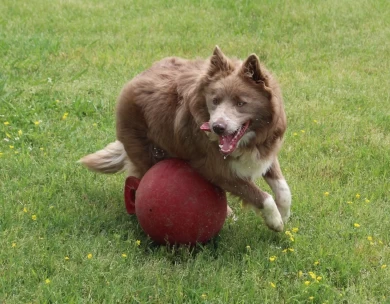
[217,180,283,232]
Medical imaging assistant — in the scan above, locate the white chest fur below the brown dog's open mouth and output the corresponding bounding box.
[229,149,272,180]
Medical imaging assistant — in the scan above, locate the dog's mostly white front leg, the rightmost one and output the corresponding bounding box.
[264,158,291,223]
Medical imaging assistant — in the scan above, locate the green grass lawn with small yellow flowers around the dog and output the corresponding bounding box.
[0,0,390,304]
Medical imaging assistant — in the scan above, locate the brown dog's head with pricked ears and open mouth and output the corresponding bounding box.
[201,47,284,155]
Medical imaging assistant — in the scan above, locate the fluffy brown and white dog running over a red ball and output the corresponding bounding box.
[80,46,291,232]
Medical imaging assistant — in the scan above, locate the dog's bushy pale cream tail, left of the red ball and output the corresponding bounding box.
[78,140,130,173]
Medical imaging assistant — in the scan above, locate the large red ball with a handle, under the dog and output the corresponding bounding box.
[125,159,227,245]
